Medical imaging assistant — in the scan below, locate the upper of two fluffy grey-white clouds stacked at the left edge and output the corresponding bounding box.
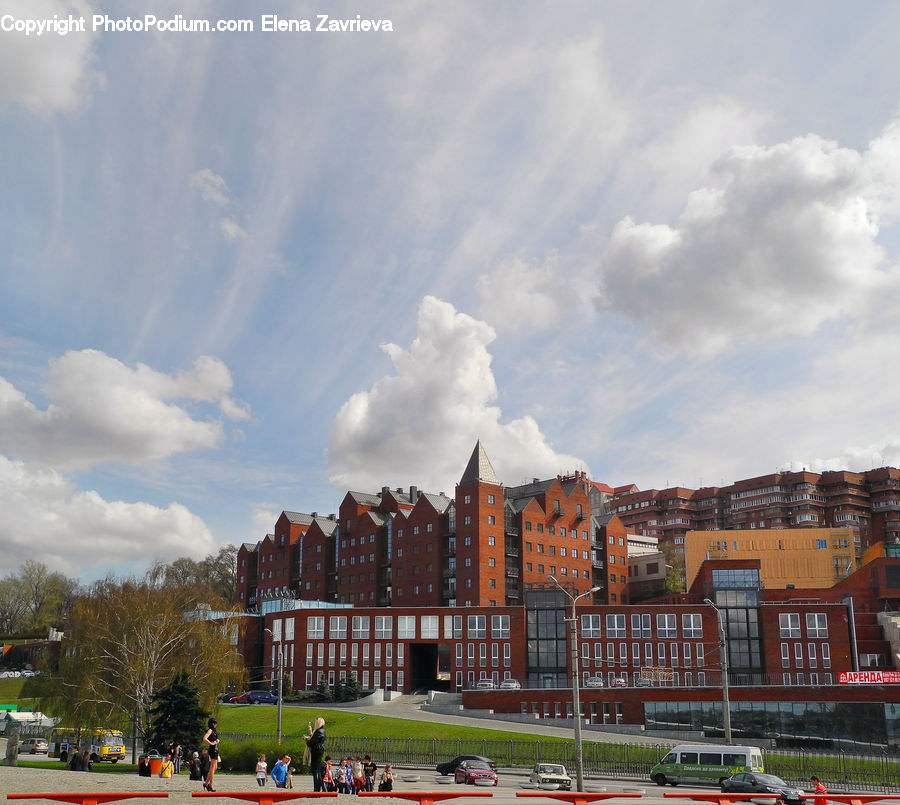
[0,350,249,469]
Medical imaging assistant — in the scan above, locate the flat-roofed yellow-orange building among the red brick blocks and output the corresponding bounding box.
[684,528,857,589]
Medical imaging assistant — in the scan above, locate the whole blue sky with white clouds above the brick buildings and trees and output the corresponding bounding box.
[0,0,900,582]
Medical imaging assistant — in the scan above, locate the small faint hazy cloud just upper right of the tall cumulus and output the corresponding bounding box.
[475,257,589,333]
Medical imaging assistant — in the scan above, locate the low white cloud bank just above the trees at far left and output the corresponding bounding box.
[0,456,216,577]
